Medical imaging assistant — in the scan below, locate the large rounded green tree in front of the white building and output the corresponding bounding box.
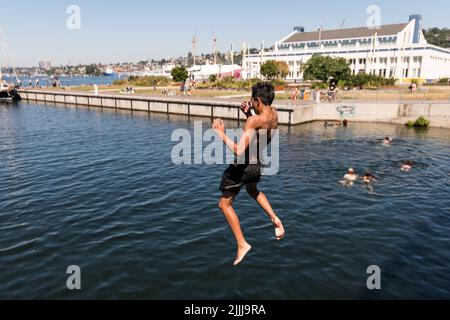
[303,54,351,82]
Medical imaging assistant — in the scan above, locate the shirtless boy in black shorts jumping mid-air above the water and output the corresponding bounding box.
[212,82,285,265]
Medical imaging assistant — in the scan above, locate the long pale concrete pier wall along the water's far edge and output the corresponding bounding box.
[20,90,450,128]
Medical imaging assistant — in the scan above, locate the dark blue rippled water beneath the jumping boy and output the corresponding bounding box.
[0,102,450,299]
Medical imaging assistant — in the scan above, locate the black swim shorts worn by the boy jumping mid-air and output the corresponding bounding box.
[220,164,261,198]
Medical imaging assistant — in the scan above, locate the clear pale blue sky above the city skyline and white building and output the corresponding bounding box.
[0,0,450,66]
